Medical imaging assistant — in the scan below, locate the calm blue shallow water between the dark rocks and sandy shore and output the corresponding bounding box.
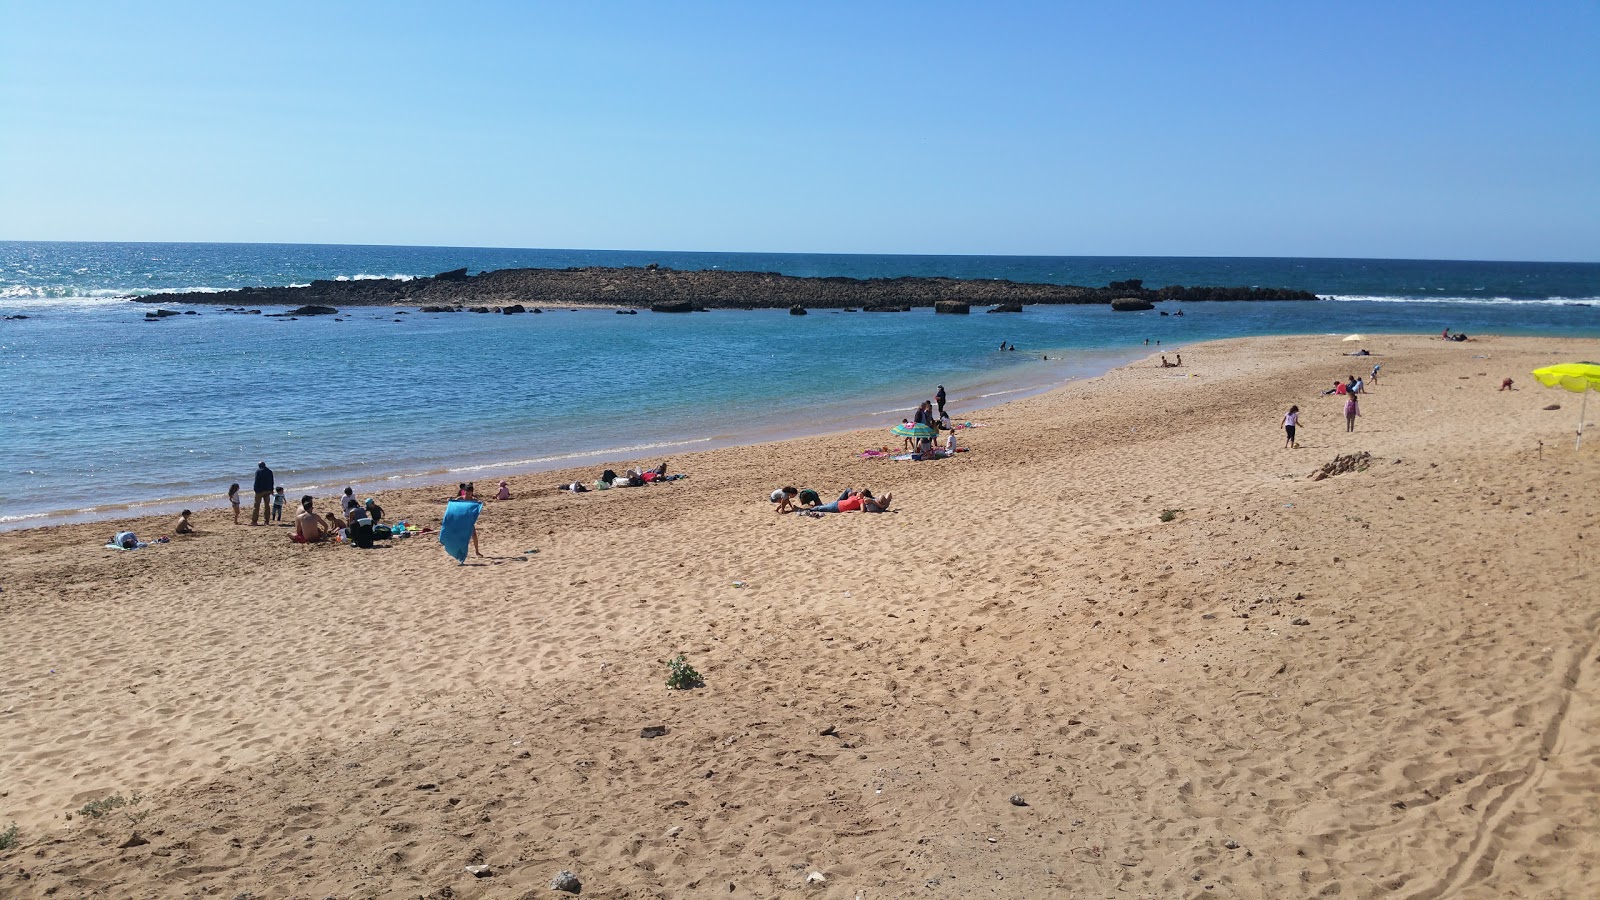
[9,245,1600,528]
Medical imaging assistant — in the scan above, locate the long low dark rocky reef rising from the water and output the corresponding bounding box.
[138,266,1317,311]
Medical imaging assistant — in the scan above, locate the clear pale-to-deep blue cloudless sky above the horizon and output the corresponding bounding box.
[0,0,1600,261]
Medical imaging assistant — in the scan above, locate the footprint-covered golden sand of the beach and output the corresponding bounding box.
[0,336,1600,898]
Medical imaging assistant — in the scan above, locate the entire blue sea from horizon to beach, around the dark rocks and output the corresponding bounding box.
[0,242,1600,528]
